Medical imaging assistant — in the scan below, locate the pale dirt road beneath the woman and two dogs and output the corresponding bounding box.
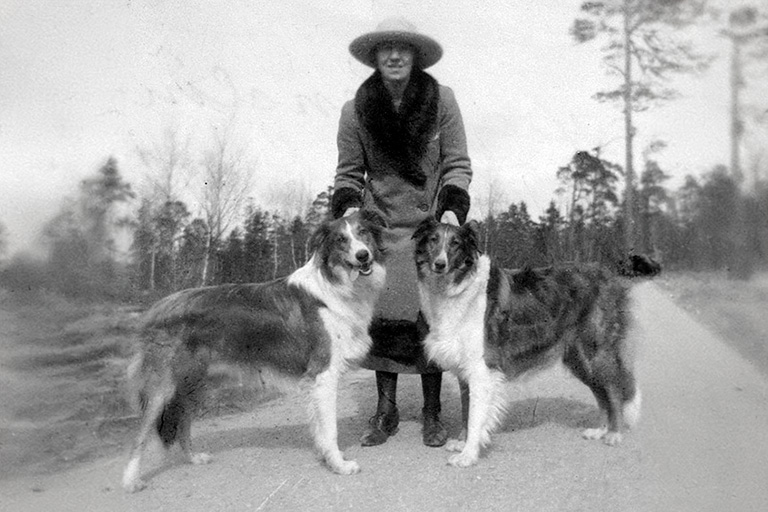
[0,283,768,512]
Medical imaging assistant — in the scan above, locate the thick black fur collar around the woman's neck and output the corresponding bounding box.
[355,69,440,187]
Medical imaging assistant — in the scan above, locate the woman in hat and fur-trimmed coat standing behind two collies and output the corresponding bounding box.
[331,18,472,446]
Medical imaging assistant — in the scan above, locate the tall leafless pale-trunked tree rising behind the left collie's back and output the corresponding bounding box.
[201,125,253,284]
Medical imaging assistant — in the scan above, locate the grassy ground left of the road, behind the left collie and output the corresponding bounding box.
[0,293,278,479]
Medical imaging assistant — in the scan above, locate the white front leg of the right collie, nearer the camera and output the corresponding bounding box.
[448,363,503,468]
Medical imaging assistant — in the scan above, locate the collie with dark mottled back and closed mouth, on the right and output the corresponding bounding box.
[414,220,640,467]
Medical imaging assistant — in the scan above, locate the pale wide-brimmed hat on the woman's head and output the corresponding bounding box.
[349,18,443,69]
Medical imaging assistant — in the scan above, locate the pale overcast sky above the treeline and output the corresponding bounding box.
[0,0,768,256]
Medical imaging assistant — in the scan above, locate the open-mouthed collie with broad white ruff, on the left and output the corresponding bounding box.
[123,211,385,492]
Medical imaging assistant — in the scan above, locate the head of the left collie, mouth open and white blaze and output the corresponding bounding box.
[310,210,386,281]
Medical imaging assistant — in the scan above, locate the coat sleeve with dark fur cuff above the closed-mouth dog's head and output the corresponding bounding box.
[435,87,472,224]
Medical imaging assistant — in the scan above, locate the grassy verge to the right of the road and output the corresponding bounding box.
[655,272,768,376]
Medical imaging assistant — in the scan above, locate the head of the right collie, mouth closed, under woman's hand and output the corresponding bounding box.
[413,219,480,283]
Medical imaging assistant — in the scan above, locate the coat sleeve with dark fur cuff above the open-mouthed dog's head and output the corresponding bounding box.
[331,101,367,219]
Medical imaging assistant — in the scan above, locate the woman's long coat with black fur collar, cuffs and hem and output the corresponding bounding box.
[331,70,472,373]
